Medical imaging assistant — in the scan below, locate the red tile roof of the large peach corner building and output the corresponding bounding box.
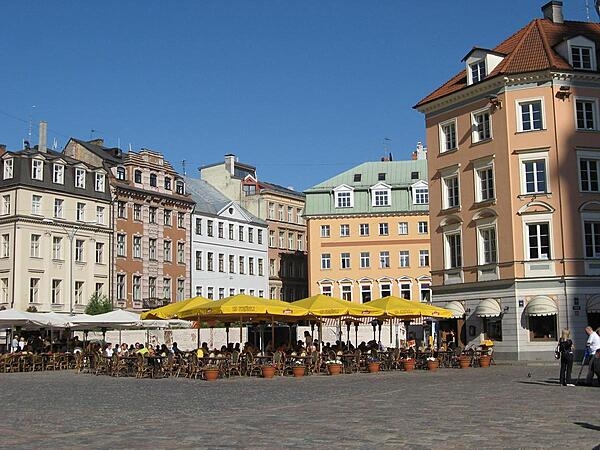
[415,19,600,108]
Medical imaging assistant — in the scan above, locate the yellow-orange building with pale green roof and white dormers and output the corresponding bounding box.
[304,156,431,303]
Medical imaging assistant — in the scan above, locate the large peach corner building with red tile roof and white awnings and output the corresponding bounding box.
[415,1,600,359]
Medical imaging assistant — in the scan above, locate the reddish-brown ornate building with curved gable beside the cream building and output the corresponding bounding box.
[64,139,194,310]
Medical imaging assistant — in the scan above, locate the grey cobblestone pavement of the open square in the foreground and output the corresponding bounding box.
[0,365,600,448]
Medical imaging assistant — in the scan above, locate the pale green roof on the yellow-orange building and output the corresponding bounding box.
[304,159,429,216]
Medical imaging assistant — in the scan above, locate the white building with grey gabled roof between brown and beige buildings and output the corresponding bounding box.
[184,178,269,299]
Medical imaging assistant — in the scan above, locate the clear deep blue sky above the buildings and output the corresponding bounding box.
[0,0,598,190]
